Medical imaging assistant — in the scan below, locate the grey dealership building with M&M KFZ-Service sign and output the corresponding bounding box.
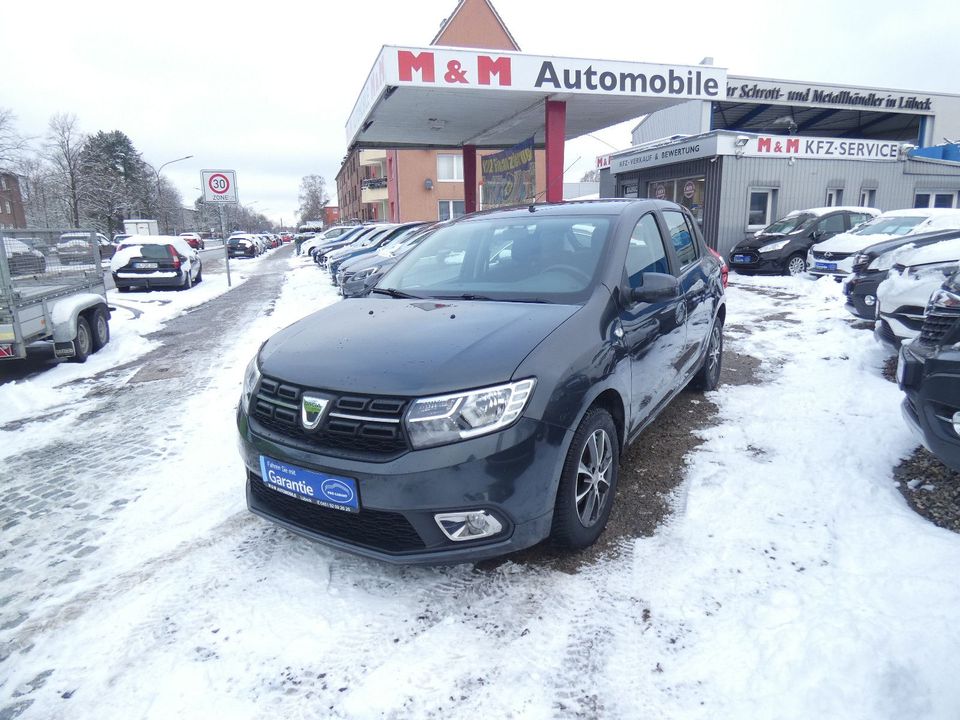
[598,75,960,252]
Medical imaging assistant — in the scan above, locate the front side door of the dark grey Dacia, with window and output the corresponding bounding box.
[620,211,686,433]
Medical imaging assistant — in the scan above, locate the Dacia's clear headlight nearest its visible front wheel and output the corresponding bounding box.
[406,378,537,448]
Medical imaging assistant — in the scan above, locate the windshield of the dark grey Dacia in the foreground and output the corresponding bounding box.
[380,214,611,303]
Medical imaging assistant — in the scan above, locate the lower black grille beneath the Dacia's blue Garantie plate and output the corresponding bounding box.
[247,471,426,554]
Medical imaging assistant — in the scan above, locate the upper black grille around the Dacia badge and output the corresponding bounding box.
[252,377,409,460]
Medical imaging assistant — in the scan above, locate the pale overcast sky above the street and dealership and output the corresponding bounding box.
[0,0,960,222]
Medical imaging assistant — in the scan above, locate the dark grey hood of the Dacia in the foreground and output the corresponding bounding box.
[260,297,580,396]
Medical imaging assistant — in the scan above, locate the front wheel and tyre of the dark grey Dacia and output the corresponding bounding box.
[550,407,620,550]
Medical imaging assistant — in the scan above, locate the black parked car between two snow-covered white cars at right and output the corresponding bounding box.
[843,230,960,321]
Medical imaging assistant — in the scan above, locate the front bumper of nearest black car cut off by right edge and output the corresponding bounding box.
[897,343,960,471]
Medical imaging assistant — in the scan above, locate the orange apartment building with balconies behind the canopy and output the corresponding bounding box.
[337,0,546,222]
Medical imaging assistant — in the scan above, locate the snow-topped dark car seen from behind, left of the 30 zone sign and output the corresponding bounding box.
[110,235,203,292]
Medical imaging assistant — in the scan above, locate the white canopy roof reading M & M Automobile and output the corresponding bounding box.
[346,46,726,148]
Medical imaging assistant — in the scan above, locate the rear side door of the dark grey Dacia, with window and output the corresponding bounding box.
[661,210,713,378]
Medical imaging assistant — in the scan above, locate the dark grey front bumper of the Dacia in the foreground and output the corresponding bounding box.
[237,411,572,564]
